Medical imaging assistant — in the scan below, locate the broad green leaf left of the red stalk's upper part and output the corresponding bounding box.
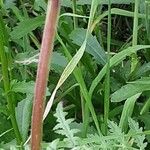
[10,16,44,40]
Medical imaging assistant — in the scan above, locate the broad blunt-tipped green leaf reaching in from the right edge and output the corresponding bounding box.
[111,77,150,102]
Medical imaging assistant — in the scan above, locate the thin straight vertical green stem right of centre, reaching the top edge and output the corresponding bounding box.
[104,0,111,135]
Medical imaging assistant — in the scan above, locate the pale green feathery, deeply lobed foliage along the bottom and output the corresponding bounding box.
[24,103,147,150]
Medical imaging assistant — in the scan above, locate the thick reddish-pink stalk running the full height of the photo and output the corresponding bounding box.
[31,0,60,150]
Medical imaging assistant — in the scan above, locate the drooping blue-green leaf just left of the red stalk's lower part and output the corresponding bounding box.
[16,94,33,142]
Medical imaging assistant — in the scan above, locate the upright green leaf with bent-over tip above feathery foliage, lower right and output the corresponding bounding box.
[119,93,141,131]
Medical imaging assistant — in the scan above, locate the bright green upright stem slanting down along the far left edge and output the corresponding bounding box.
[0,15,22,145]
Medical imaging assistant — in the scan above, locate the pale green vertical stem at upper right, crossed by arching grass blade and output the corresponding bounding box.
[131,0,139,73]
